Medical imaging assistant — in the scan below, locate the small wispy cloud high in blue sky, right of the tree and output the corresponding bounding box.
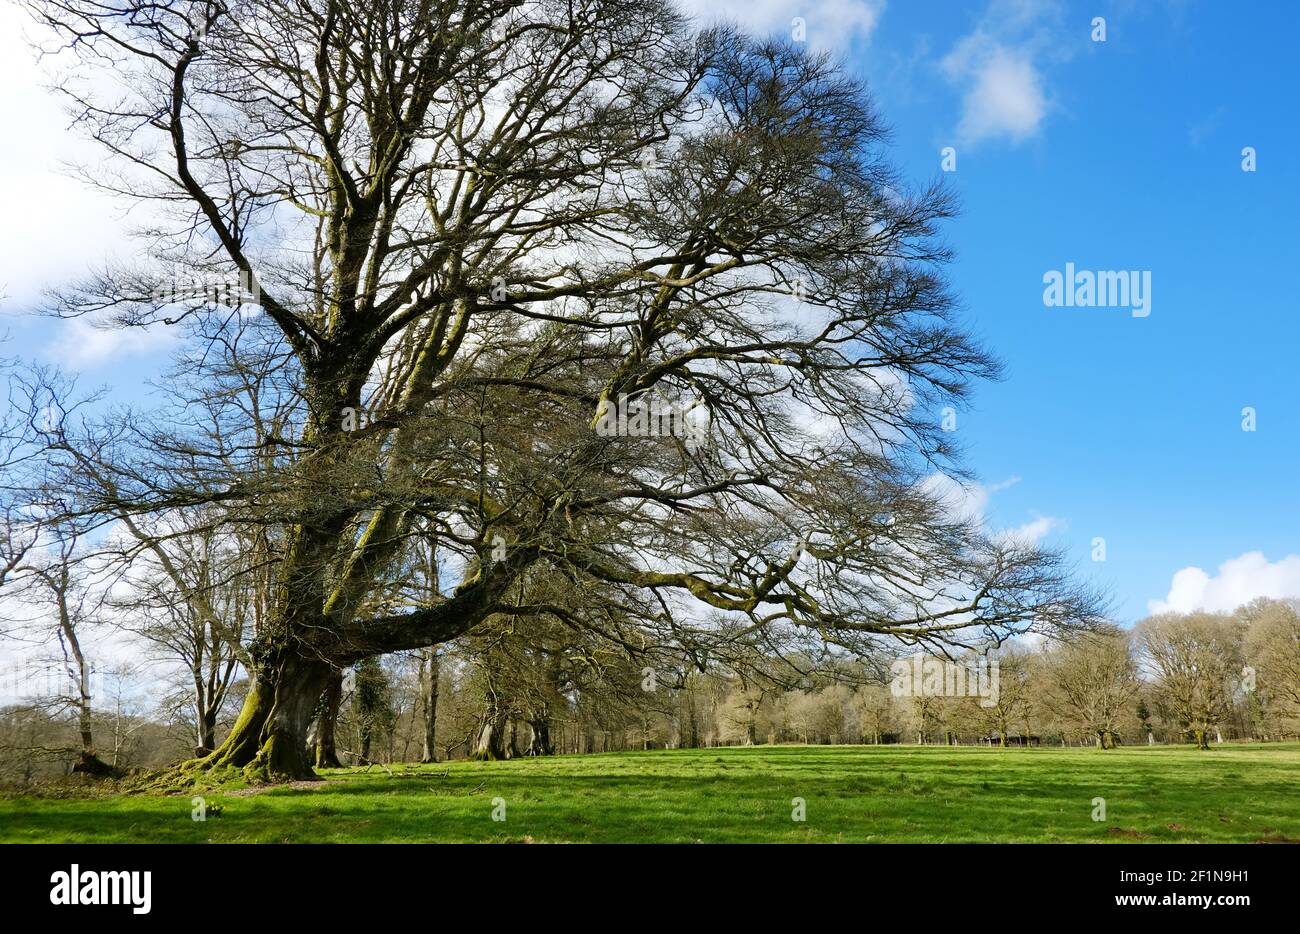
[940,0,1061,146]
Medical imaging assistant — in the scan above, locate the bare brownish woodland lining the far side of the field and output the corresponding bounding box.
[0,600,1300,786]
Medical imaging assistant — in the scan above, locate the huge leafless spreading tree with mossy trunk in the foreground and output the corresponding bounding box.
[15,0,1097,778]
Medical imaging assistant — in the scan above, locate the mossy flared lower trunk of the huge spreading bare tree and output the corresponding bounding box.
[191,654,335,782]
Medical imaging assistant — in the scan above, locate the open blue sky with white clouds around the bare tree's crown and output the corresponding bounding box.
[0,0,1300,622]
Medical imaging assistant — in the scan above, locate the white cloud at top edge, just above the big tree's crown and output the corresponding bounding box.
[680,0,885,48]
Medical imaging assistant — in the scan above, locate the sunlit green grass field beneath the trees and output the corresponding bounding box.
[0,744,1300,843]
